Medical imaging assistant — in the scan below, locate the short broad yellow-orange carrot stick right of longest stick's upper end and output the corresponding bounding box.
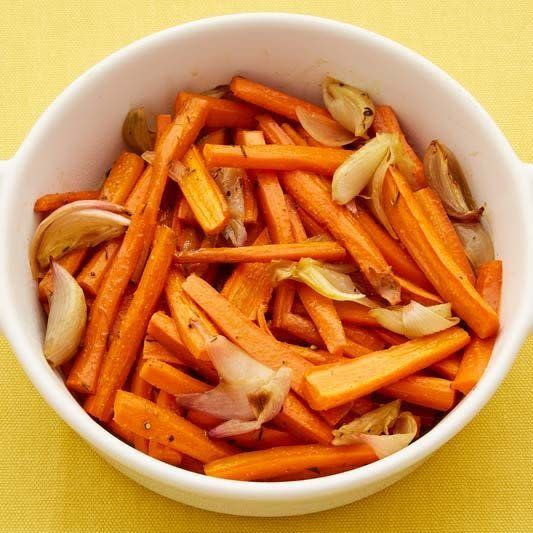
[178,145,230,235]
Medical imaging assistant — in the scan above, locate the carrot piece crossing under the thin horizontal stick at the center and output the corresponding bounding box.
[220,229,273,320]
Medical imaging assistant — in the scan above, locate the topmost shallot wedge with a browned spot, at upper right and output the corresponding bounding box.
[322,76,375,137]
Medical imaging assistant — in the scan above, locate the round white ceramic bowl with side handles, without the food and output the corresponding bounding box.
[0,14,533,516]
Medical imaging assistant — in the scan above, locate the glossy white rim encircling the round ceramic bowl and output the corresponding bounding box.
[0,13,533,502]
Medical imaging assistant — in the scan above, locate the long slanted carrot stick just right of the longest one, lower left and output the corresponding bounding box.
[85,226,176,421]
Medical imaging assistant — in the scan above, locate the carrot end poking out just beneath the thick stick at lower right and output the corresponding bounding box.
[379,374,456,411]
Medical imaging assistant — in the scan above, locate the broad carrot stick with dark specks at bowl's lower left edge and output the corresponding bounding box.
[114,391,236,462]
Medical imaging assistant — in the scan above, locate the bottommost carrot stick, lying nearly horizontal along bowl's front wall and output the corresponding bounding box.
[204,444,377,481]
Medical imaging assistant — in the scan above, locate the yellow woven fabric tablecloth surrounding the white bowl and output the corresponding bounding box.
[0,0,533,532]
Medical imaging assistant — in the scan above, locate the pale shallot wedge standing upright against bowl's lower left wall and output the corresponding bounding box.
[43,261,87,367]
